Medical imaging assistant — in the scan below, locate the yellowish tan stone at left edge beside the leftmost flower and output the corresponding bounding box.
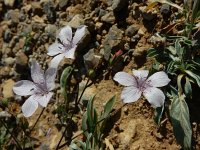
[2,79,15,98]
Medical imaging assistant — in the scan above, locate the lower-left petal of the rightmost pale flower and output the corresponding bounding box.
[121,86,142,103]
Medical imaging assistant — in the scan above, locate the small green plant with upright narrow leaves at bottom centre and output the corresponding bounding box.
[70,97,115,150]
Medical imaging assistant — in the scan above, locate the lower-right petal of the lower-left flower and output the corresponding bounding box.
[34,92,53,107]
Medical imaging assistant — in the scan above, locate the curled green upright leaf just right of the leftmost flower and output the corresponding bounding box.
[60,66,73,101]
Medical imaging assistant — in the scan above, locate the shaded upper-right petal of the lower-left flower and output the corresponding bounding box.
[45,68,57,91]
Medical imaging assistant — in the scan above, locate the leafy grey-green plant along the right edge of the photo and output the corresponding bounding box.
[148,0,200,149]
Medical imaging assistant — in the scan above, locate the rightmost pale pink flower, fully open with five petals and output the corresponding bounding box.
[114,70,170,107]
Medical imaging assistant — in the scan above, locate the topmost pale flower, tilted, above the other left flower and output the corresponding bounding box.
[47,26,86,68]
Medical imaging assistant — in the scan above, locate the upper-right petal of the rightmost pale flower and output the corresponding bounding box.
[146,71,170,87]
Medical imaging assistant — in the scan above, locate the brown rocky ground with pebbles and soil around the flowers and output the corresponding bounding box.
[0,0,200,150]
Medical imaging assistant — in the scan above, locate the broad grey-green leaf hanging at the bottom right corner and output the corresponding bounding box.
[170,92,192,149]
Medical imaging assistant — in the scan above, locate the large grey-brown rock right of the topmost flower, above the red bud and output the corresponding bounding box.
[103,25,123,60]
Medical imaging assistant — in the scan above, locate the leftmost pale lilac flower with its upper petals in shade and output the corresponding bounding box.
[13,60,56,117]
